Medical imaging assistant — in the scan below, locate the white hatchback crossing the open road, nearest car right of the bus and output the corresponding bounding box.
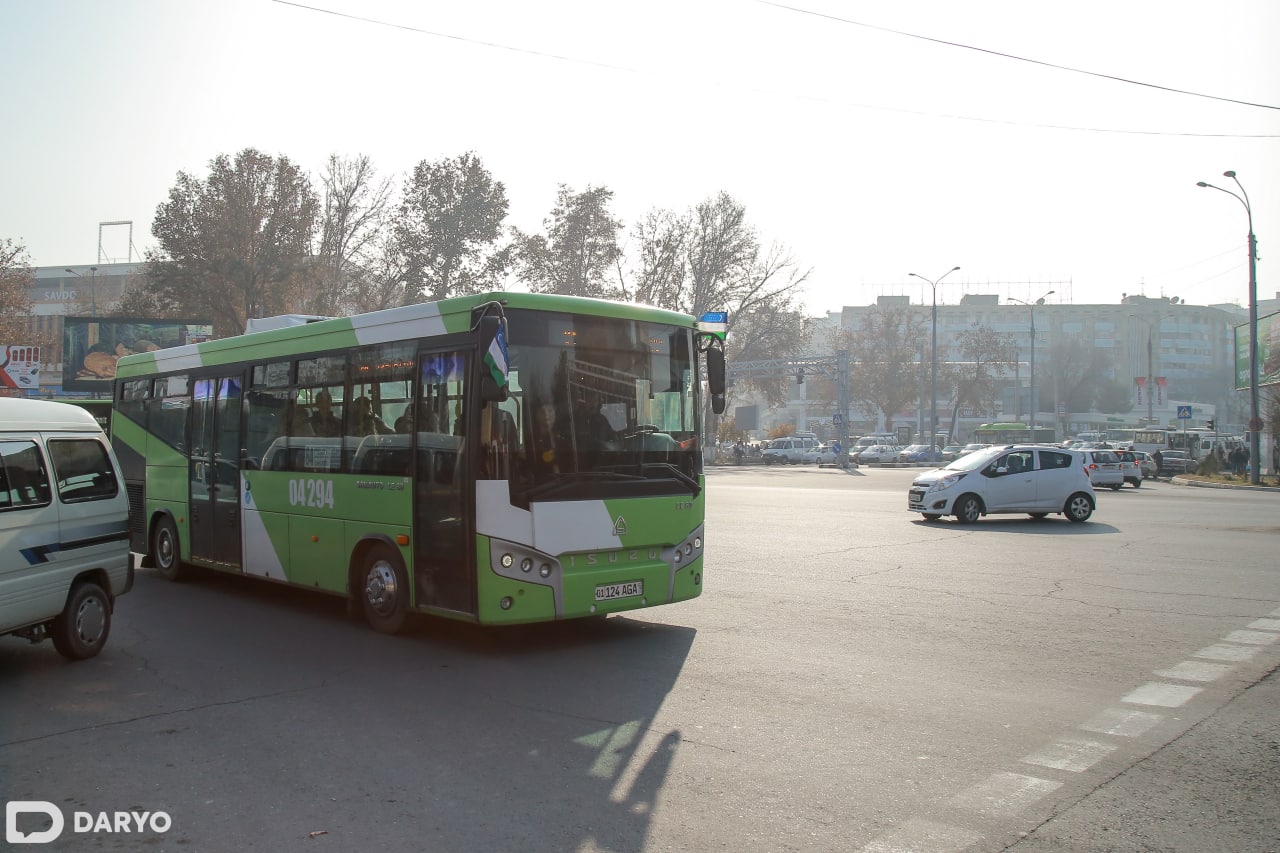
[906,444,1097,524]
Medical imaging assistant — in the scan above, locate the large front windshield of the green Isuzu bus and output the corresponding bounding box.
[499,310,701,505]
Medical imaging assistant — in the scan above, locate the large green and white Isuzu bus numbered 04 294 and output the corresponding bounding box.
[113,293,726,633]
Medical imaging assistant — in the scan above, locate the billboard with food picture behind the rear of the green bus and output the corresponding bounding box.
[63,316,214,393]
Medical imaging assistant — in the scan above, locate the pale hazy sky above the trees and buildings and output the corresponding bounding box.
[0,0,1280,314]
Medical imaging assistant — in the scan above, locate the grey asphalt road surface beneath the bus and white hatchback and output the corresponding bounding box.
[0,466,1280,853]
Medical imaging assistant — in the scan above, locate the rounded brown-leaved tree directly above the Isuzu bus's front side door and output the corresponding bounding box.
[387,151,511,304]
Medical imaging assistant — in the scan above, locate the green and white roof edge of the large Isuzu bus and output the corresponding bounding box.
[115,292,694,378]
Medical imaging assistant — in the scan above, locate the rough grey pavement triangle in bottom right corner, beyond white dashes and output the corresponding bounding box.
[1007,669,1280,853]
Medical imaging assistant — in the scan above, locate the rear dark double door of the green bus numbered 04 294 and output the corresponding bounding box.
[188,375,242,569]
